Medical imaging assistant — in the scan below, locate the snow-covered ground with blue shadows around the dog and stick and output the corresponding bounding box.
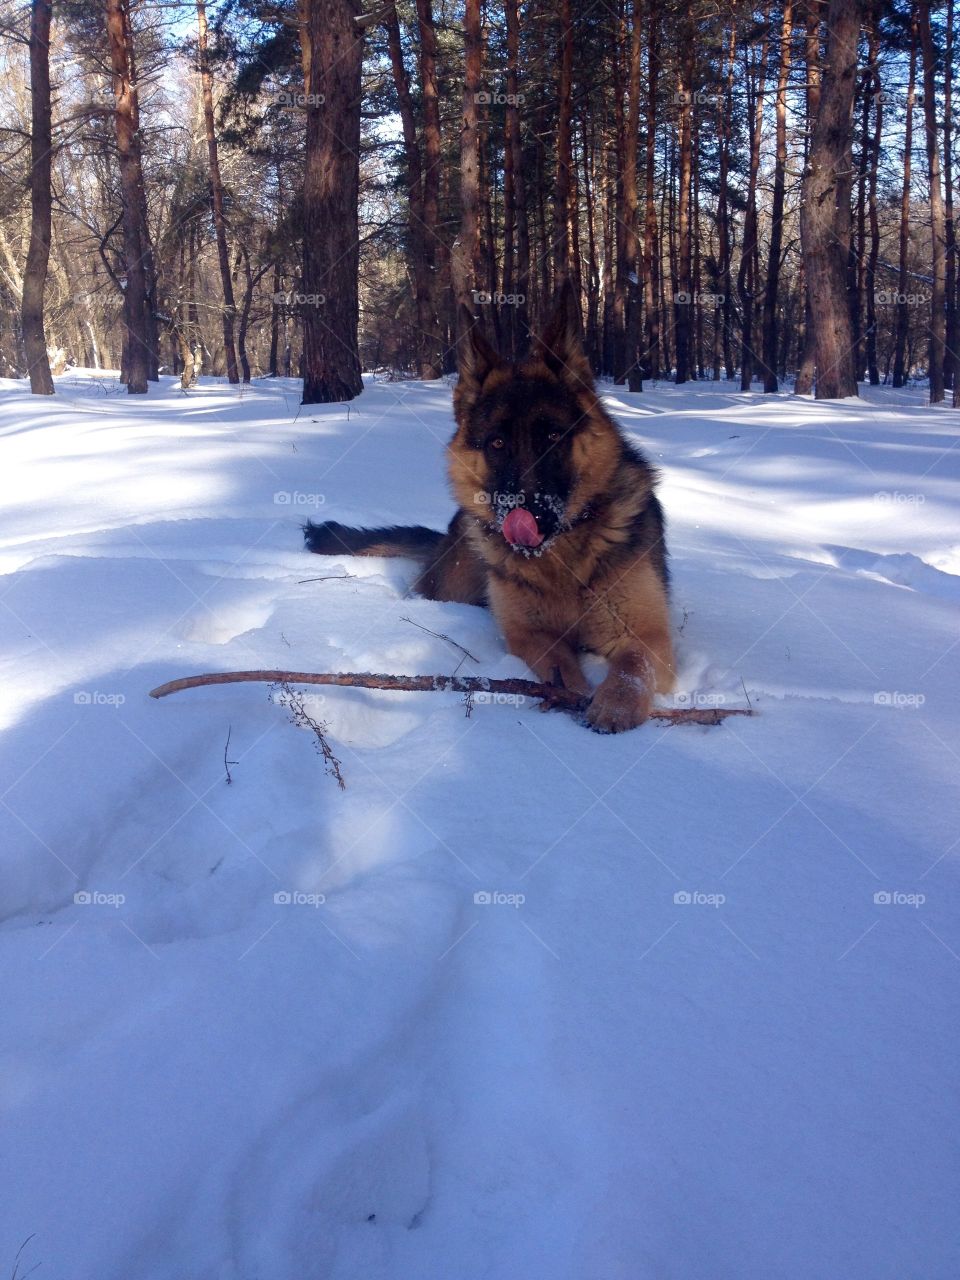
[0,372,960,1280]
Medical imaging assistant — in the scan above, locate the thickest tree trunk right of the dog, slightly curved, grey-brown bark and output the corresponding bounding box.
[800,0,860,399]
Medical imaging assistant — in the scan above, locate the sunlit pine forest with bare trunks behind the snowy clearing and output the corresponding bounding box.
[0,0,960,403]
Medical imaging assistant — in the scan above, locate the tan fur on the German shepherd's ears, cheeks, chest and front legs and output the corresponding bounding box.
[449,291,675,732]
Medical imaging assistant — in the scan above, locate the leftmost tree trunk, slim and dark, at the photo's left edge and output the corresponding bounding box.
[20,0,54,396]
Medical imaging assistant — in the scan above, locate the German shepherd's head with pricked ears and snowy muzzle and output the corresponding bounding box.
[451,284,617,556]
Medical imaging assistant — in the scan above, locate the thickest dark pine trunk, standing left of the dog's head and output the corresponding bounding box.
[301,0,364,404]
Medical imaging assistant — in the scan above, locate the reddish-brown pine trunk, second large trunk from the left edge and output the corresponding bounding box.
[106,0,150,396]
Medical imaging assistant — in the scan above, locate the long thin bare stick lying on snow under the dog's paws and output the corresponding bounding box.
[150,671,756,724]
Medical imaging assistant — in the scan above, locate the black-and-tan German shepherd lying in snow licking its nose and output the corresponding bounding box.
[305,284,675,733]
